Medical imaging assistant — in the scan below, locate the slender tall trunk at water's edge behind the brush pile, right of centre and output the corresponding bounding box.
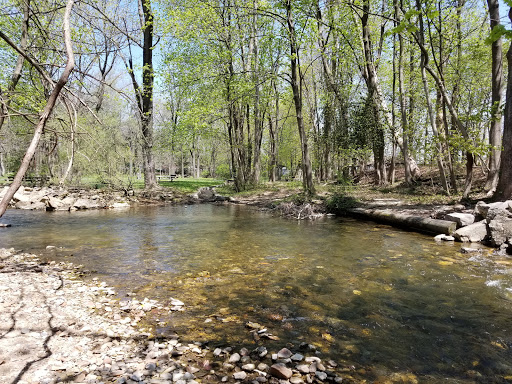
[285,0,315,198]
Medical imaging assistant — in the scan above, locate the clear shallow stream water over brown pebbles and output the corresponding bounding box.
[0,205,512,383]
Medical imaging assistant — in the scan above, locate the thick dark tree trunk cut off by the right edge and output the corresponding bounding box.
[493,8,512,200]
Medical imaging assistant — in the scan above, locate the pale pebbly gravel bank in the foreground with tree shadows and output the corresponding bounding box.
[0,249,400,384]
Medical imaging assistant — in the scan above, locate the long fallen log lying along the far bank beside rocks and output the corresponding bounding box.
[347,208,457,235]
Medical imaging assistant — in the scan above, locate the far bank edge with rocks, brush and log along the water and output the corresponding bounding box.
[0,186,512,253]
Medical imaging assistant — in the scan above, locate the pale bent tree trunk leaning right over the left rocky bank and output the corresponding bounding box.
[0,0,75,217]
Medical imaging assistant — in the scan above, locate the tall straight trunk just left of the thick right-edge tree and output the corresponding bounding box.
[484,0,503,194]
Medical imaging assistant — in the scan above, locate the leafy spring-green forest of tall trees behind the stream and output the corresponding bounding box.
[0,0,512,206]
